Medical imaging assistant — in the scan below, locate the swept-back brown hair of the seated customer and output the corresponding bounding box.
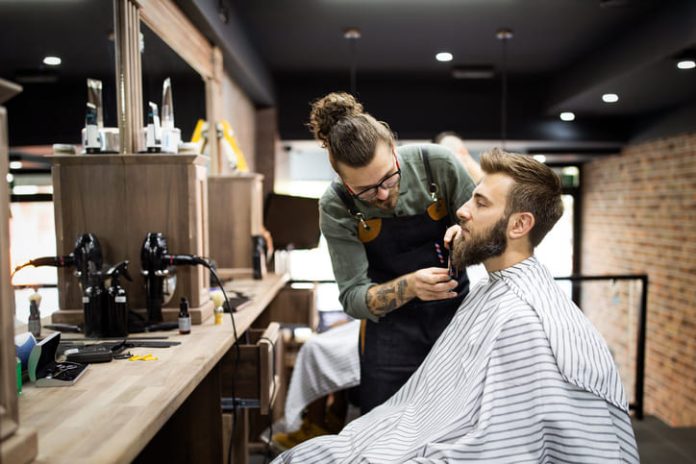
[481,148,563,248]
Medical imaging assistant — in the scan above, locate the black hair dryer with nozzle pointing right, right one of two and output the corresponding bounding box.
[140,232,208,322]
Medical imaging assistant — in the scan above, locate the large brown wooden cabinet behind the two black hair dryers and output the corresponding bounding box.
[53,154,212,323]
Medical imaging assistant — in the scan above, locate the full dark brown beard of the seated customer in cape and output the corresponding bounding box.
[452,216,509,271]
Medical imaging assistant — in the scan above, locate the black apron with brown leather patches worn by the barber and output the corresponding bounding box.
[332,150,469,414]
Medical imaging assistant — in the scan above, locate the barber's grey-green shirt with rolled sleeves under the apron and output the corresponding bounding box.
[319,144,474,321]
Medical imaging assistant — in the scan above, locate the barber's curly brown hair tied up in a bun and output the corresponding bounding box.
[307,92,394,170]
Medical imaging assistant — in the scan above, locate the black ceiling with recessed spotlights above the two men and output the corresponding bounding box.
[222,0,696,146]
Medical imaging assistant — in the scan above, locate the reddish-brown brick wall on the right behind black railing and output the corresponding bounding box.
[582,134,696,426]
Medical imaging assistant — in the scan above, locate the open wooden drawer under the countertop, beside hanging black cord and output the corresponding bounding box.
[221,322,283,414]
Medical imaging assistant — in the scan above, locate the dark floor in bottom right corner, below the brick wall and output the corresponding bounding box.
[249,417,696,464]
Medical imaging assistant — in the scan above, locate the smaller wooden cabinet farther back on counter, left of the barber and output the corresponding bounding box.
[208,173,263,269]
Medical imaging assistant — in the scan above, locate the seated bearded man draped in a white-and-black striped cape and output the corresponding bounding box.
[277,150,639,463]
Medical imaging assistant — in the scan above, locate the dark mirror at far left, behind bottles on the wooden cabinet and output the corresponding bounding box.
[0,0,116,147]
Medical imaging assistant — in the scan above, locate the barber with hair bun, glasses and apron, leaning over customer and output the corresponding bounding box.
[309,93,474,414]
